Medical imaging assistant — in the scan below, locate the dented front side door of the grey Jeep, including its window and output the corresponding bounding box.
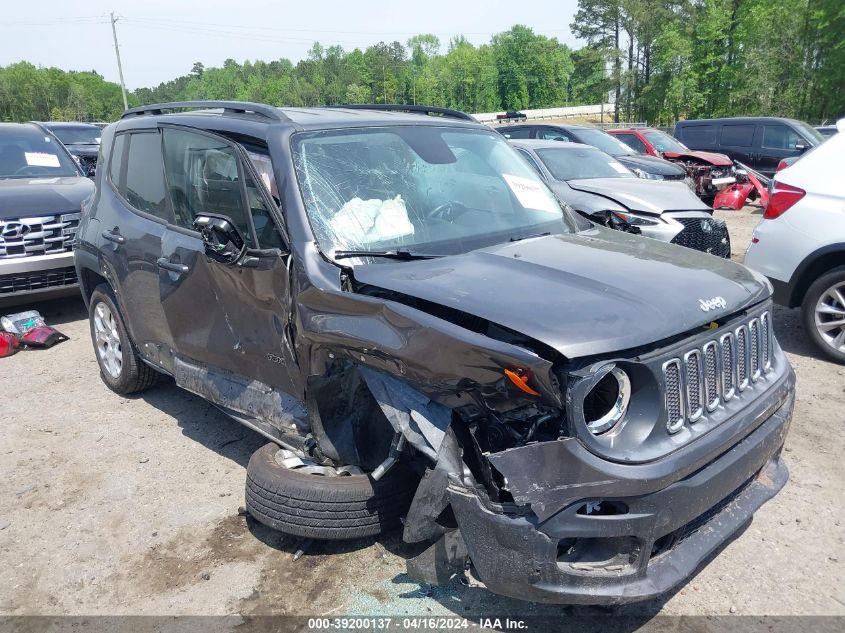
[159,126,296,396]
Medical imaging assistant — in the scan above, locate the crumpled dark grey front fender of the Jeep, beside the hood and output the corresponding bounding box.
[297,288,563,408]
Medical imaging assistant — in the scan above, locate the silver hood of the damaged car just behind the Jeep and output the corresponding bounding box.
[566,178,712,215]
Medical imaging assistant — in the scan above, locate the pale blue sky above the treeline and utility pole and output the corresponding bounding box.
[0,0,579,89]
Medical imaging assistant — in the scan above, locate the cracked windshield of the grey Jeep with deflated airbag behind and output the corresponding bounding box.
[293,126,576,261]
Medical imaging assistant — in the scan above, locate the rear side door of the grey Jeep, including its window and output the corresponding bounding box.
[98,129,172,358]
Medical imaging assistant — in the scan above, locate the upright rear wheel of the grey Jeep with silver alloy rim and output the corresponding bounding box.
[88,284,159,395]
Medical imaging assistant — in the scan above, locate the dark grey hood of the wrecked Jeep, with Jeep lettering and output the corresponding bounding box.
[354,227,770,358]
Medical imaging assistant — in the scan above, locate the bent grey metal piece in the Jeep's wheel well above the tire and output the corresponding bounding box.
[360,367,452,461]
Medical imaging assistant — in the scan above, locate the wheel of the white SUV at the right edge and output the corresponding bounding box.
[801,267,845,363]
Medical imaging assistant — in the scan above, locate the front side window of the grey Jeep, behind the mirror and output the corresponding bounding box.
[164,128,254,246]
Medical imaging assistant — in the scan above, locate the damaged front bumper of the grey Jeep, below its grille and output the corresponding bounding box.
[449,369,794,604]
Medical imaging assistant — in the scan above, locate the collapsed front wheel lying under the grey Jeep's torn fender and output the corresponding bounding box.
[246,444,419,540]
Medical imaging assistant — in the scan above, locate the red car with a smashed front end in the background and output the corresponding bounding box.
[607,127,736,203]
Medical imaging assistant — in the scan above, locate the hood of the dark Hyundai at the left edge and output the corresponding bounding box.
[0,176,94,218]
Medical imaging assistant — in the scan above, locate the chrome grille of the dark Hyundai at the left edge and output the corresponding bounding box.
[0,212,80,259]
